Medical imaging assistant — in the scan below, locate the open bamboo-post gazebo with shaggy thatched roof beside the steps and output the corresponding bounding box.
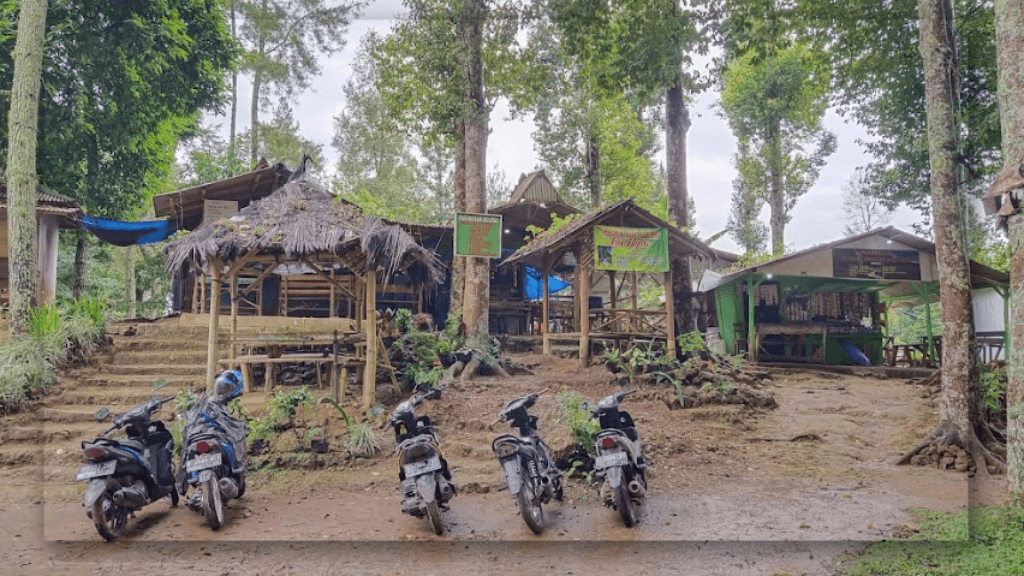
[165,169,443,404]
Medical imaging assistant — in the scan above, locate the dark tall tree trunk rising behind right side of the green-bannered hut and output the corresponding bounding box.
[665,75,694,333]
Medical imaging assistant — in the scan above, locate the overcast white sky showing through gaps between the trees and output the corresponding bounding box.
[207,0,918,251]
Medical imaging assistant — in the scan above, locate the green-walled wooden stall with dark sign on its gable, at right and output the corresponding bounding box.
[701,227,1009,365]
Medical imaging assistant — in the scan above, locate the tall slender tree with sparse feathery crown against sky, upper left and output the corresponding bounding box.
[239,0,357,166]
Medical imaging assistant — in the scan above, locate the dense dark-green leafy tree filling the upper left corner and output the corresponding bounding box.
[0,0,238,295]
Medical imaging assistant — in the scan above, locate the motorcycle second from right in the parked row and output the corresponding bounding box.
[490,393,563,534]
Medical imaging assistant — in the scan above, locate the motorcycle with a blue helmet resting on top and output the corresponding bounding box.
[178,370,248,530]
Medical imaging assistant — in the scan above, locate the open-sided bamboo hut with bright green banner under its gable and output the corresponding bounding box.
[502,200,715,367]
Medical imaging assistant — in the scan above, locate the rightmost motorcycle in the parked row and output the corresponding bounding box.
[592,390,647,528]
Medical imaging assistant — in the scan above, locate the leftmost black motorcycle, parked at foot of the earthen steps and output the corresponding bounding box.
[75,389,178,540]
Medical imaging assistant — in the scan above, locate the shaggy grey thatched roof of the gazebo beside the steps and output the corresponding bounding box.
[165,176,442,284]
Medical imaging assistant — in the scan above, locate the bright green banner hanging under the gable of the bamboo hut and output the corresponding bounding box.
[594,227,669,272]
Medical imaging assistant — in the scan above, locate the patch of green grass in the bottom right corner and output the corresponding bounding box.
[837,506,1024,576]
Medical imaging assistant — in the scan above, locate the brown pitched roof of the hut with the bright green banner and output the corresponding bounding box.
[502,199,714,268]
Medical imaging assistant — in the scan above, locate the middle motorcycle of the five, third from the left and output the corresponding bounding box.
[384,389,458,536]
